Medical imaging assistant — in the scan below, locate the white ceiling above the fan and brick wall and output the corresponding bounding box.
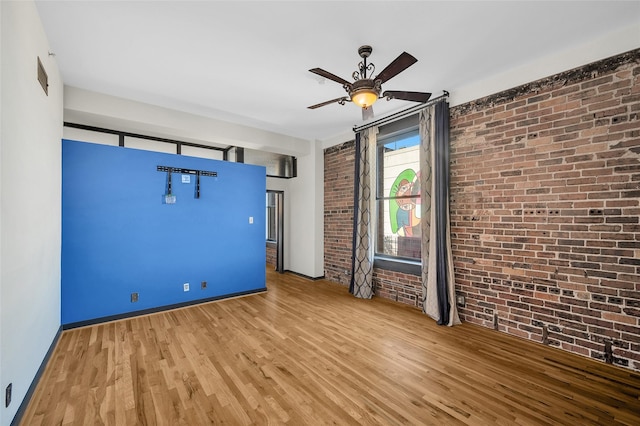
[36,0,640,140]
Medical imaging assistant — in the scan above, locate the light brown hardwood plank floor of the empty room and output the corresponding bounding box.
[21,271,640,426]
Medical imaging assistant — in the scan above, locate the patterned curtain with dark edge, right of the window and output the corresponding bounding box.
[420,100,460,325]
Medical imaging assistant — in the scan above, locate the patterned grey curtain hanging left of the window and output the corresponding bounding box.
[349,128,377,299]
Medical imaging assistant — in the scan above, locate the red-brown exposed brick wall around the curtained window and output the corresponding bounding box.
[325,50,640,370]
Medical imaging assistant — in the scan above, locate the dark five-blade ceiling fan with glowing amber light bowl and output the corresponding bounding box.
[308,45,431,120]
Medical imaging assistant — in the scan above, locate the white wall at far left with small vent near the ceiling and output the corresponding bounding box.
[0,1,63,425]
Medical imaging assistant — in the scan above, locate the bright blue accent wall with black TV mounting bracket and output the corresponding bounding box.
[61,140,266,325]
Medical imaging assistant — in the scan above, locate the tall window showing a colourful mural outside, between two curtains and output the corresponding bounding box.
[376,115,421,270]
